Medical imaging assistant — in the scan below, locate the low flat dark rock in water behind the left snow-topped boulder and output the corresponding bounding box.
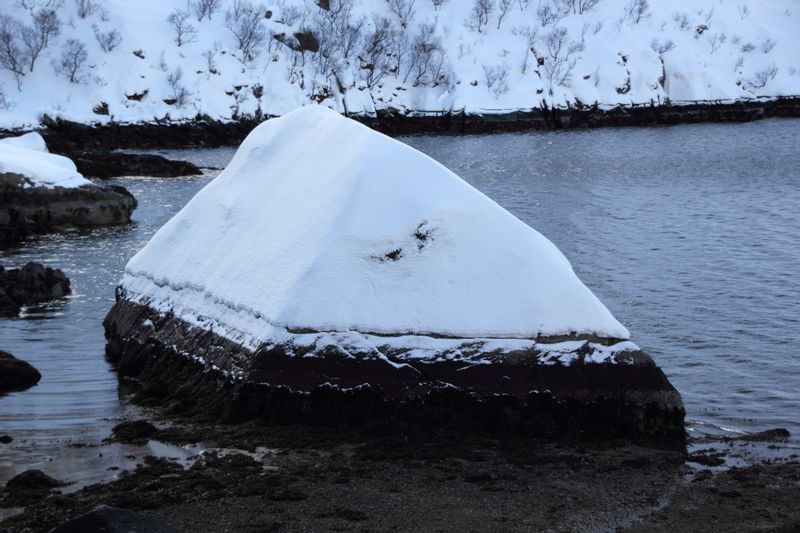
[69,152,202,179]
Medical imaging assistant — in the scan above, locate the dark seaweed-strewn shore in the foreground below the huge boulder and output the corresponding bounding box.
[0,416,800,532]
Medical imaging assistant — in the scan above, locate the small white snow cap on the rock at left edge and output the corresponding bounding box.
[0,133,91,187]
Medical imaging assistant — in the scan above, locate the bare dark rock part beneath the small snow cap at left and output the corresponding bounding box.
[0,173,137,246]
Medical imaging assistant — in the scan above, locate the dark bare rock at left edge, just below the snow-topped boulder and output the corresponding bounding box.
[0,263,71,316]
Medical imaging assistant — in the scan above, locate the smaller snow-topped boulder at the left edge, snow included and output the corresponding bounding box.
[0,133,137,246]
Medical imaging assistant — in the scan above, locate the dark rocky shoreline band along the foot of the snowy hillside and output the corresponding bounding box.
[0,96,800,152]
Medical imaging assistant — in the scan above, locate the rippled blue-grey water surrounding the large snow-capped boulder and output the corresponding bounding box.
[0,120,800,479]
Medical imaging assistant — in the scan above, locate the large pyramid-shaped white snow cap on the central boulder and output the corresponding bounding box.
[122,106,629,340]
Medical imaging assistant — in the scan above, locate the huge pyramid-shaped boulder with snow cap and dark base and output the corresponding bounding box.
[105,106,684,446]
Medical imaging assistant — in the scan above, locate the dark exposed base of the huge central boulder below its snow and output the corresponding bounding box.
[104,298,685,449]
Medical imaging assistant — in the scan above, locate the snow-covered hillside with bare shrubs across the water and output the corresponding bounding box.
[0,0,800,128]
